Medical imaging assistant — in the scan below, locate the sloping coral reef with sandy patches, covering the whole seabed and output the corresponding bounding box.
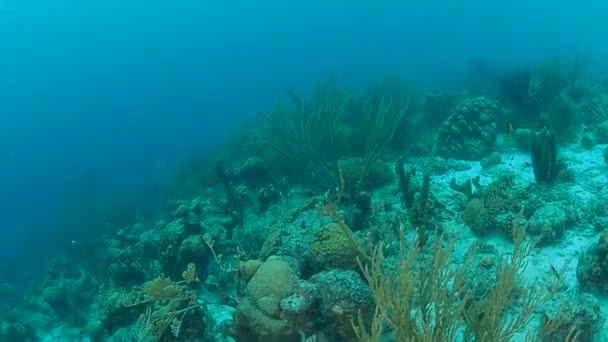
[8,70,608,342]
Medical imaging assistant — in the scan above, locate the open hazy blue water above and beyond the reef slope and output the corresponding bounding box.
[0,0,608,280]
